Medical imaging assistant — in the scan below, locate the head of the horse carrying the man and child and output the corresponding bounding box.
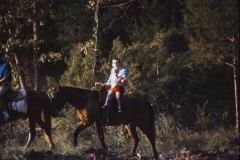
[51,85,66,117]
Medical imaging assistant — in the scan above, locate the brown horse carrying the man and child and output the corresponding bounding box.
[52,86,158,159]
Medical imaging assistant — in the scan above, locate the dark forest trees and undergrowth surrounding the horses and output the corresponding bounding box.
[0,0,239,157]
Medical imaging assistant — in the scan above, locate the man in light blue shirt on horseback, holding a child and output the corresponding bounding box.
[95,57,128,123]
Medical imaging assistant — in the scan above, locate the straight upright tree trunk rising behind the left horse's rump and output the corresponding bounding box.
[33,0,39,90]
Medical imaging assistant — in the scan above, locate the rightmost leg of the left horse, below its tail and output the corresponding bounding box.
[37,119,55,150]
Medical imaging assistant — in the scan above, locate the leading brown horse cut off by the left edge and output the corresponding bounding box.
[2,89,55,150]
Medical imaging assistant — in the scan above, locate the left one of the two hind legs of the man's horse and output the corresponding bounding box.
[125,123,139,156]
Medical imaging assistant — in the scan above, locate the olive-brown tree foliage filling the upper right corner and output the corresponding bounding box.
[183,0,239,64]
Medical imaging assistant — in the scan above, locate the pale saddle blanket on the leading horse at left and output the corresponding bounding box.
[8,89,27,114]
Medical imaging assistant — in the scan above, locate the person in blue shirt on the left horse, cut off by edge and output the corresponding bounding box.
[0,52,12,123]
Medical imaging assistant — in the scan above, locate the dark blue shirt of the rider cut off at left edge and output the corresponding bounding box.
[0,60,12,83]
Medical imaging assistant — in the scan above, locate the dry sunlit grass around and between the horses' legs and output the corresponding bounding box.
[0,111,239,160]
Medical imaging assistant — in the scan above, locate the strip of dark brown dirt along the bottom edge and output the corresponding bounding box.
[24,148,239,160]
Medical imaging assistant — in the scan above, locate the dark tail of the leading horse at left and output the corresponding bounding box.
[39,91,51,129]
